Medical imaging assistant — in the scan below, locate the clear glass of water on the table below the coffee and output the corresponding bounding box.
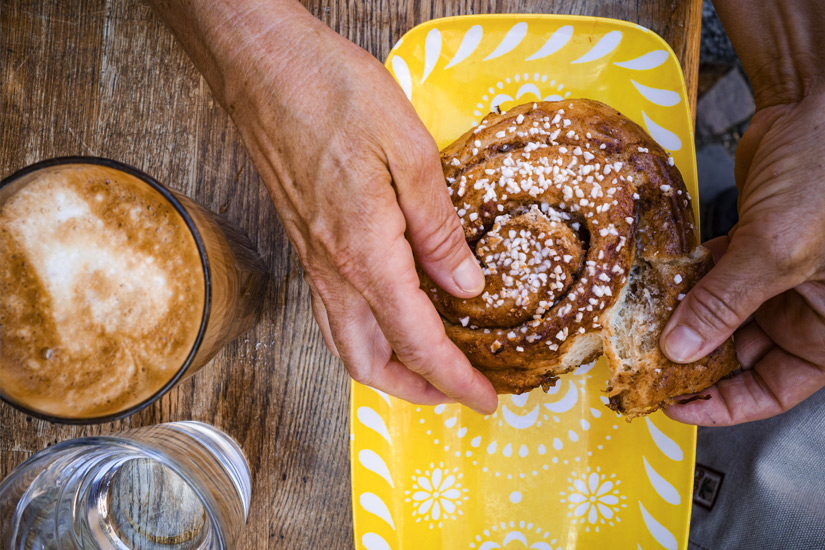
[0,422,251,550]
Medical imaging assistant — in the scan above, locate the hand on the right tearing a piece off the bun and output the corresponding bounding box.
[661,94,825,426]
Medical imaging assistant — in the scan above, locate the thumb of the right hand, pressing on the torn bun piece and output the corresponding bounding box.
[660,243,793,363]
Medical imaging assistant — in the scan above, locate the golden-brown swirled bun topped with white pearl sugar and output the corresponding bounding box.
[419,99,738,417]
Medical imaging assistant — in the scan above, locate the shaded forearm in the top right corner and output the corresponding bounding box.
[714,0,825,108]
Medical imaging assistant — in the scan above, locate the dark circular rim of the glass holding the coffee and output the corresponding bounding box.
[0,155,212,425]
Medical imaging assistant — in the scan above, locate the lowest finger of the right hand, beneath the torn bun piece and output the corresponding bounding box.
[665,347,825,426]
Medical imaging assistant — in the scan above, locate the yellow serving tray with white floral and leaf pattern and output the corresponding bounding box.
[351,15,699,550]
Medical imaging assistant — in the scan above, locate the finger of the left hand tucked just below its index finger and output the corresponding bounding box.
[320,274,453,405]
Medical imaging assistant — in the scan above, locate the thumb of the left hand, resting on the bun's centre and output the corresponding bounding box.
[388,132,484,298]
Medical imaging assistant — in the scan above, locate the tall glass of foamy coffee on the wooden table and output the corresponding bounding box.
[0,157,267,423]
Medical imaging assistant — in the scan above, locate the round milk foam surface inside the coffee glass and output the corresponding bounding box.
[0,165,205,418]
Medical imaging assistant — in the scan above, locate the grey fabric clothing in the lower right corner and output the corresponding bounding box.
[688,390,825,550]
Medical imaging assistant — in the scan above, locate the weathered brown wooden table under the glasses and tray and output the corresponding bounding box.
[0,0,701,550]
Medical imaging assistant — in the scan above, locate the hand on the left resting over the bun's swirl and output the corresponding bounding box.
[149,0,497,412]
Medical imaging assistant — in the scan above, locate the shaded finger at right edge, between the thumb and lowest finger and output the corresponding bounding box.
[754,282,825,365]
